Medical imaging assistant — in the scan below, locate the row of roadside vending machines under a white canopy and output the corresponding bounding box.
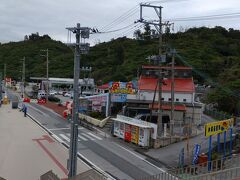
[113,115,157,147]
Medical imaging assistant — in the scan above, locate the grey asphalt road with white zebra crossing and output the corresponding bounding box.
[8,89,166,180]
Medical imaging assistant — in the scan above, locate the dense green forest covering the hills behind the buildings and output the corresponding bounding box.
[0,27,240,113]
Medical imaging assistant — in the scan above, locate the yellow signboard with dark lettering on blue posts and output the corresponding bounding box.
[205,118,234,137]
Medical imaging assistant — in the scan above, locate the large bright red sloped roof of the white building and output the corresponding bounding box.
[138,77,195,93]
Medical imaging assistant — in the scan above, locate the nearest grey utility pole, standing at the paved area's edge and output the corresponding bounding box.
[66,23,90,177]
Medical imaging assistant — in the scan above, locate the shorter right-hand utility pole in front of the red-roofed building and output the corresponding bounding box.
[170,49,176,135]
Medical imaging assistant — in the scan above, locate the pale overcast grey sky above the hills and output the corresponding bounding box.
[0,0,240,44]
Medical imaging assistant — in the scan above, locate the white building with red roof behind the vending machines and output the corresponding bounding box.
[125,66,202,135]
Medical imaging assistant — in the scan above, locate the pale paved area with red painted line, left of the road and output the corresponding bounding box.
[0,104,90,180]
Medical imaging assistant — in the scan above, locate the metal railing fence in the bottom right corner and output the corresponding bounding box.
[139,155,240,180]
